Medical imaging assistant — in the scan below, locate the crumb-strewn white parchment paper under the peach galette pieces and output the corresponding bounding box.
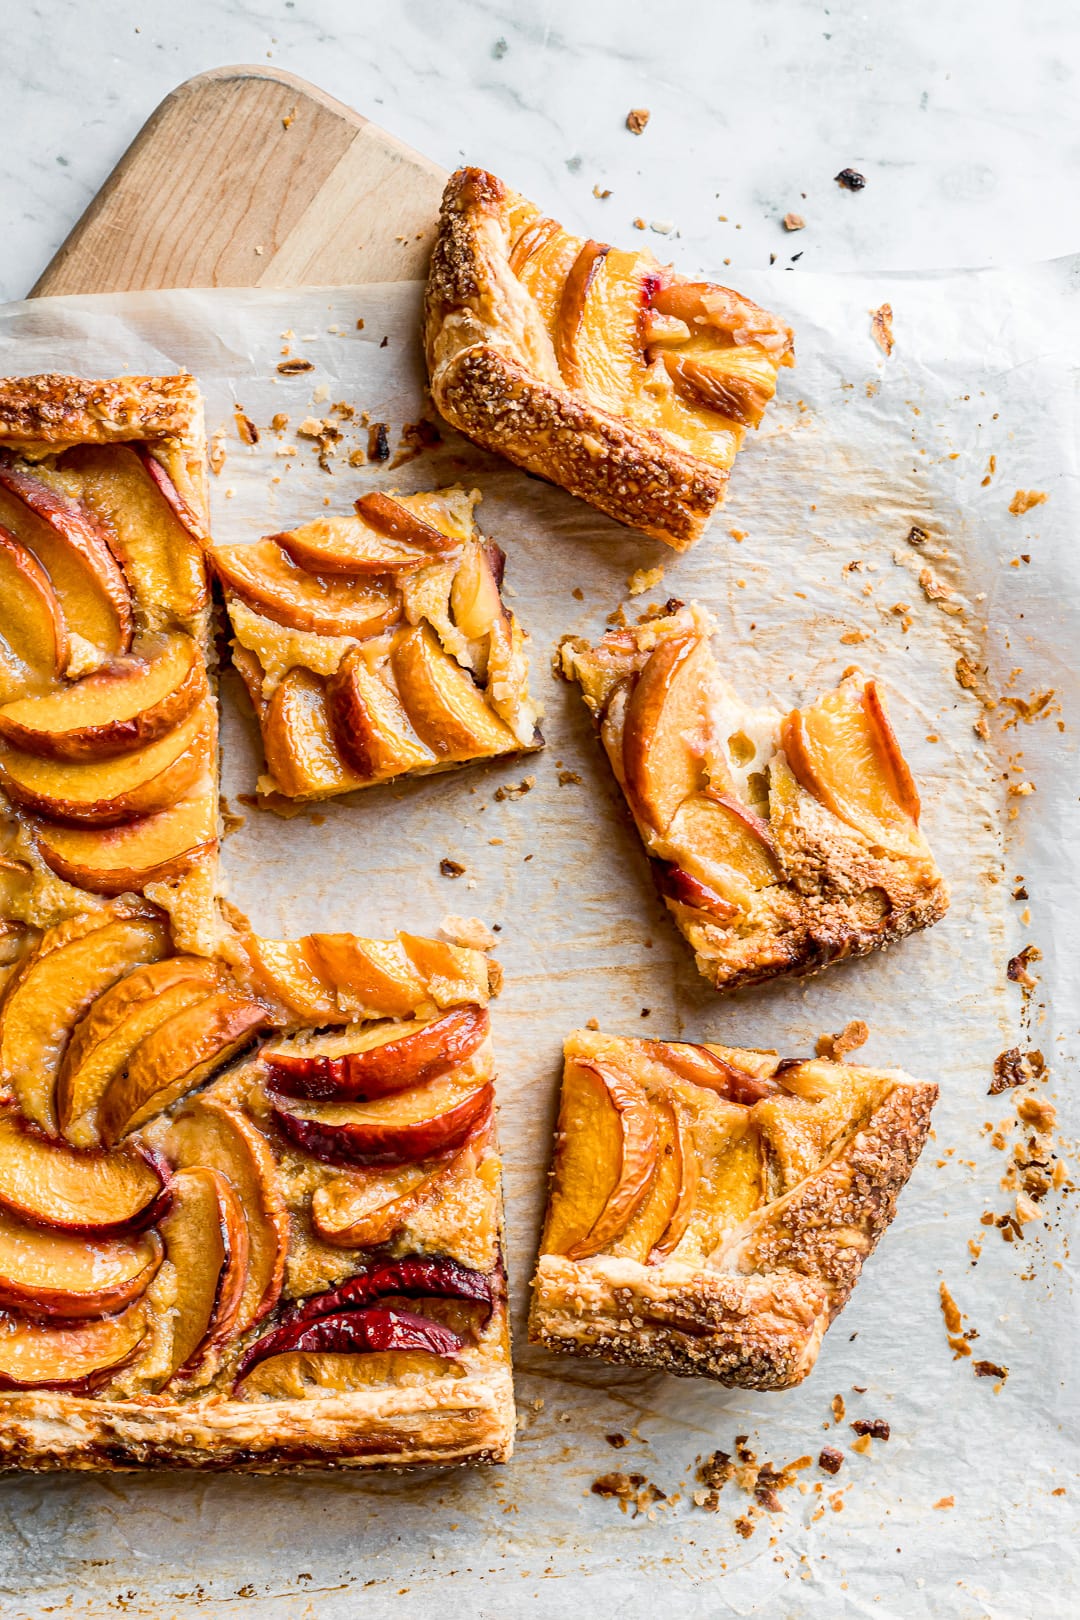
[0,261,1080,1620]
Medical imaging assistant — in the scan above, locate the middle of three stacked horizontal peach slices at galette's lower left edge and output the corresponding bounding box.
[0,1213,162,1322]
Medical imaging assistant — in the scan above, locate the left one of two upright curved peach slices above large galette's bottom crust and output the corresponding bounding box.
[160,1165,248,1377]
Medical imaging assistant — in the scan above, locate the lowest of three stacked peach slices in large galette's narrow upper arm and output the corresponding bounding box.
[28,789,217,894]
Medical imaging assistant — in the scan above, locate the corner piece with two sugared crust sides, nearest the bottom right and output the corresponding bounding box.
[529,1030,938,1390]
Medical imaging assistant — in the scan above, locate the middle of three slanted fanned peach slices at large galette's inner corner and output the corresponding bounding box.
[57,956,222,1147]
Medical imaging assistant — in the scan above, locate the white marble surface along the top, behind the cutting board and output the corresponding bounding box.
[0,0,1080,298]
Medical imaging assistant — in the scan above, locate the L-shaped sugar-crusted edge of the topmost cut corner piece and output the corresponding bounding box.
[424,168,738,551]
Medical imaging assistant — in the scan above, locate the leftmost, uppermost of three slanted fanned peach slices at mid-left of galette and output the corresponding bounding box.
[0,910,168,1131]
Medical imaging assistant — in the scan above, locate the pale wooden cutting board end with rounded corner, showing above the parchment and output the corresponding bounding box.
[31,66,445,298]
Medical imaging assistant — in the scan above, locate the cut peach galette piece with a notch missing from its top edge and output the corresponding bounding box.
[560,603,949,990]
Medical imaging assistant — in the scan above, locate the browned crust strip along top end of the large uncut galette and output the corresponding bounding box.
[0,373,202,450]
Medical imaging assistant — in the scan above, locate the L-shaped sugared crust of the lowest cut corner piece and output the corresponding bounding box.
[529,1081,938,1390]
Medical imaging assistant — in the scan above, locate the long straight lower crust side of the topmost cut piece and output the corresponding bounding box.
[431,345,727,551]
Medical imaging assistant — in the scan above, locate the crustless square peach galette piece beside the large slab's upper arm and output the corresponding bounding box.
[210,489,541,799]
